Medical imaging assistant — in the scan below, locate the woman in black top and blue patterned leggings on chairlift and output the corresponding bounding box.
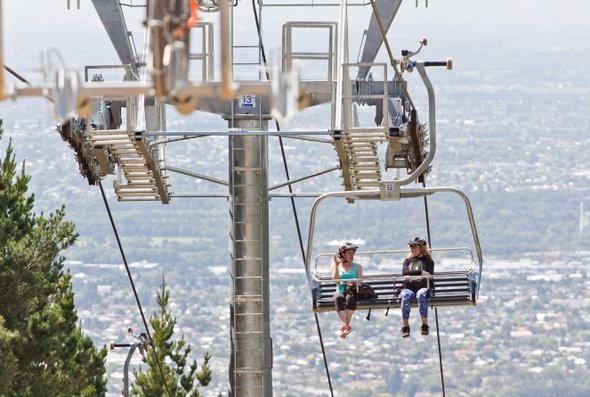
[400,237,434,338]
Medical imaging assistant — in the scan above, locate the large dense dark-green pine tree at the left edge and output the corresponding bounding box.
[0,120,107,397]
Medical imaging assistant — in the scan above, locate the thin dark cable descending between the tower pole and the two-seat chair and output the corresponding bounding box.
[252,0,334,397]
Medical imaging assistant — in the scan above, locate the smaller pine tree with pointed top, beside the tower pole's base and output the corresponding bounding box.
[131,280,211,397]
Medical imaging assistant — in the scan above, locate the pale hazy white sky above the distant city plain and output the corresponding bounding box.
[2,0,590,79]
